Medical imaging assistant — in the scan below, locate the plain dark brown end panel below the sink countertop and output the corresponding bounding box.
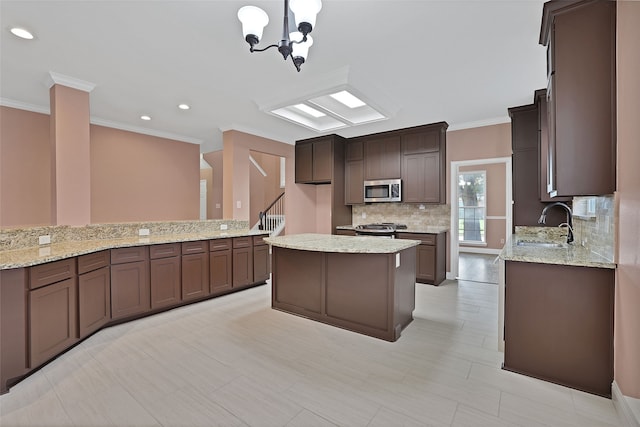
[504,261,615,397]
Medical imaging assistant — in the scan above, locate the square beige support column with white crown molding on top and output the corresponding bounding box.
[49,73,94,226]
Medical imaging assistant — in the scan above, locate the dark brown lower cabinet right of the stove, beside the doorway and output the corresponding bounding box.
[397,233,447,286]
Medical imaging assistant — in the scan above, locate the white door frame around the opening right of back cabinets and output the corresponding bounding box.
[447,157,513,280]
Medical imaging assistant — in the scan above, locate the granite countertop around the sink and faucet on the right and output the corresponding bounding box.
[500,234,616,269]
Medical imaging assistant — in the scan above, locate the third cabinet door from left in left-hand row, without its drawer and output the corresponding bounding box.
[111,260,151,320]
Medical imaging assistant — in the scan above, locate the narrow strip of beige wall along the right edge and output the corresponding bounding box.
[614,1,640,399]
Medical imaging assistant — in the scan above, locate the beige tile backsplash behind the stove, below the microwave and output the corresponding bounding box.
[351,203,451,228]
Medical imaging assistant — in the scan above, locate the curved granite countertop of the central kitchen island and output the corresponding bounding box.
[264,234,420,254]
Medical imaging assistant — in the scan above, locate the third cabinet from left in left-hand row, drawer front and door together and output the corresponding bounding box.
[111,246,151,320]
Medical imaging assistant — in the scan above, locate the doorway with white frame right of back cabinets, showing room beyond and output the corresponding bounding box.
[447,157,512,281]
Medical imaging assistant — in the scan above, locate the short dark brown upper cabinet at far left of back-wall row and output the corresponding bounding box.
[296,136,334,184]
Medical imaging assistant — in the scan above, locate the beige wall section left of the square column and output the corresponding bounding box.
[0,107,51,228]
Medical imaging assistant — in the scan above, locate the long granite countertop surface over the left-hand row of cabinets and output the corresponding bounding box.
[0,229,269,270]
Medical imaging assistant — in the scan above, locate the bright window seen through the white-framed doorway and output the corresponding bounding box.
[458,171,486,244]
